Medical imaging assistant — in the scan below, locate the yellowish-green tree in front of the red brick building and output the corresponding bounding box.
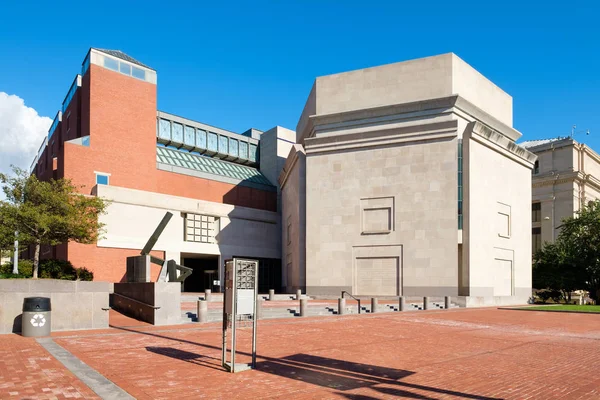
[0,167,107,278]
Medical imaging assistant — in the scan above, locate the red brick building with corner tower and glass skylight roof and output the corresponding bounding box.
[31,48,295,290]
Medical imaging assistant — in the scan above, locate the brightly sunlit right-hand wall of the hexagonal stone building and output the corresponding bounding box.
[463,123,531,298]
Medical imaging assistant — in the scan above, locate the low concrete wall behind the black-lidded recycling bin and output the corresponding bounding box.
[0,279,110,334]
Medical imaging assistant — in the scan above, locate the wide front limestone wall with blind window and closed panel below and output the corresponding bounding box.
[306,126,458,296]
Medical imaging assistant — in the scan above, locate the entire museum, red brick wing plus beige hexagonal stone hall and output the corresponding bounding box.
[31,48,536,303]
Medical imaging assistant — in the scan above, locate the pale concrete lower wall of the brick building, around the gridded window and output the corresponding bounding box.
[94,186,281,282]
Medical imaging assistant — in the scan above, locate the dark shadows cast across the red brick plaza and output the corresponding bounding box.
[115,327,501,400]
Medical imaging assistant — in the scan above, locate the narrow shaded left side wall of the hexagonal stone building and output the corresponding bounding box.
[280,144,306,293]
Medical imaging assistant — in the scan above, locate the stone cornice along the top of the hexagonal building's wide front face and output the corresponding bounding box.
[305,120,458,155]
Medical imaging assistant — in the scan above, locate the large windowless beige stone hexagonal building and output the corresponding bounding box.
[279,54,536,305]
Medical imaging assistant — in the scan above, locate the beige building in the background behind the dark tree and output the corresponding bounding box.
[521,137,600,253]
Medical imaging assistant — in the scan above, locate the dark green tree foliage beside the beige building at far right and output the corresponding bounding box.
[533,200,600,302]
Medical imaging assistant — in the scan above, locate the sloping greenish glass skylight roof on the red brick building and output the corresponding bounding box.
[156,146,273,186]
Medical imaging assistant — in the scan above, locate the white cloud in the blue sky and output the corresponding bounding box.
[0,92,52,173]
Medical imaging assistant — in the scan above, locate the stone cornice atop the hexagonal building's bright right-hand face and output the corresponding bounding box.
[465,121,537,169]
